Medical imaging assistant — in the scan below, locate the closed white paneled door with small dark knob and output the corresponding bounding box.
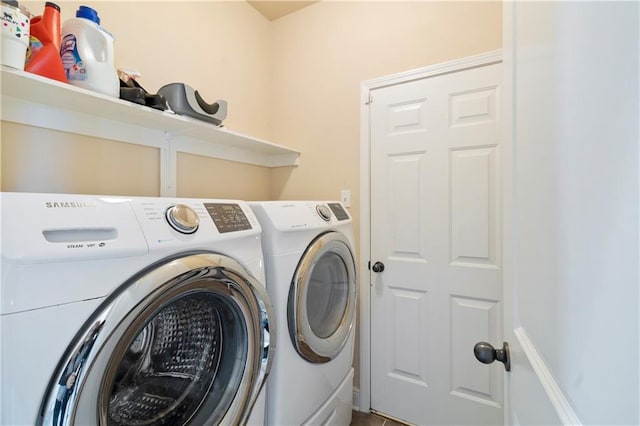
[370,64,504,425]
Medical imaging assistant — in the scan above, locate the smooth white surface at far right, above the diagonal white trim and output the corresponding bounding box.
[505,2,640,425]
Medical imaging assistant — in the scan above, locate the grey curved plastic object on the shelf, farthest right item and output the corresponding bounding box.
[158,83,227,126]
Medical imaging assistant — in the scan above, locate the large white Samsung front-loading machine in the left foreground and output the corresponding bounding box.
[0,193,275,426]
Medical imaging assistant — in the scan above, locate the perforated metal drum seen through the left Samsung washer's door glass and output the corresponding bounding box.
[100,289,249,425]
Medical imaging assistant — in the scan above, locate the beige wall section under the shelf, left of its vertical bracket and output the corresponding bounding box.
[2,122,160,196]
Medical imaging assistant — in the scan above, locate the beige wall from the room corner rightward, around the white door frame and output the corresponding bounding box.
[271,1,502,387]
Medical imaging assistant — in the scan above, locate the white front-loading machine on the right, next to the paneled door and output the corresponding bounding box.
[249,201,357,426]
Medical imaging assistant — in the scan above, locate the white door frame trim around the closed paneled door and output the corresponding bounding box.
[353,49,505,412]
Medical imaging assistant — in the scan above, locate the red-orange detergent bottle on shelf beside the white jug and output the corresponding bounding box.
[24,2,67,83]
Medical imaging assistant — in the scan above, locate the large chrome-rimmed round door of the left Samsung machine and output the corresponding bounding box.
[40,253,273,426]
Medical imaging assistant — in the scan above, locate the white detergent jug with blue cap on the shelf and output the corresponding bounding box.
[60,6,120,98]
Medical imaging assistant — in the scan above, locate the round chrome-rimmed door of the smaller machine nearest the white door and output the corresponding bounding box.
[287,232,357,363]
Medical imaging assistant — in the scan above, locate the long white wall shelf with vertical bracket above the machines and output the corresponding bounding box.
[1,66,300,196]
